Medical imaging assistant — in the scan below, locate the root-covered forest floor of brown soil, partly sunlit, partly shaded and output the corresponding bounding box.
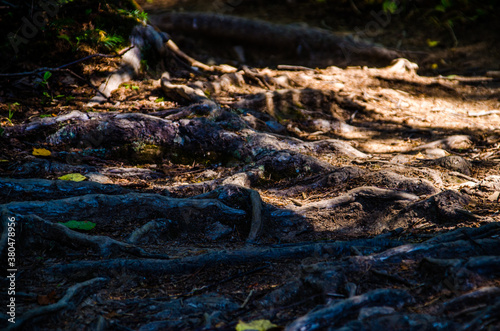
[0,1,500,330]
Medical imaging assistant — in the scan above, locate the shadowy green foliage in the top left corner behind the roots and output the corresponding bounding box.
[0,0,142,59]
